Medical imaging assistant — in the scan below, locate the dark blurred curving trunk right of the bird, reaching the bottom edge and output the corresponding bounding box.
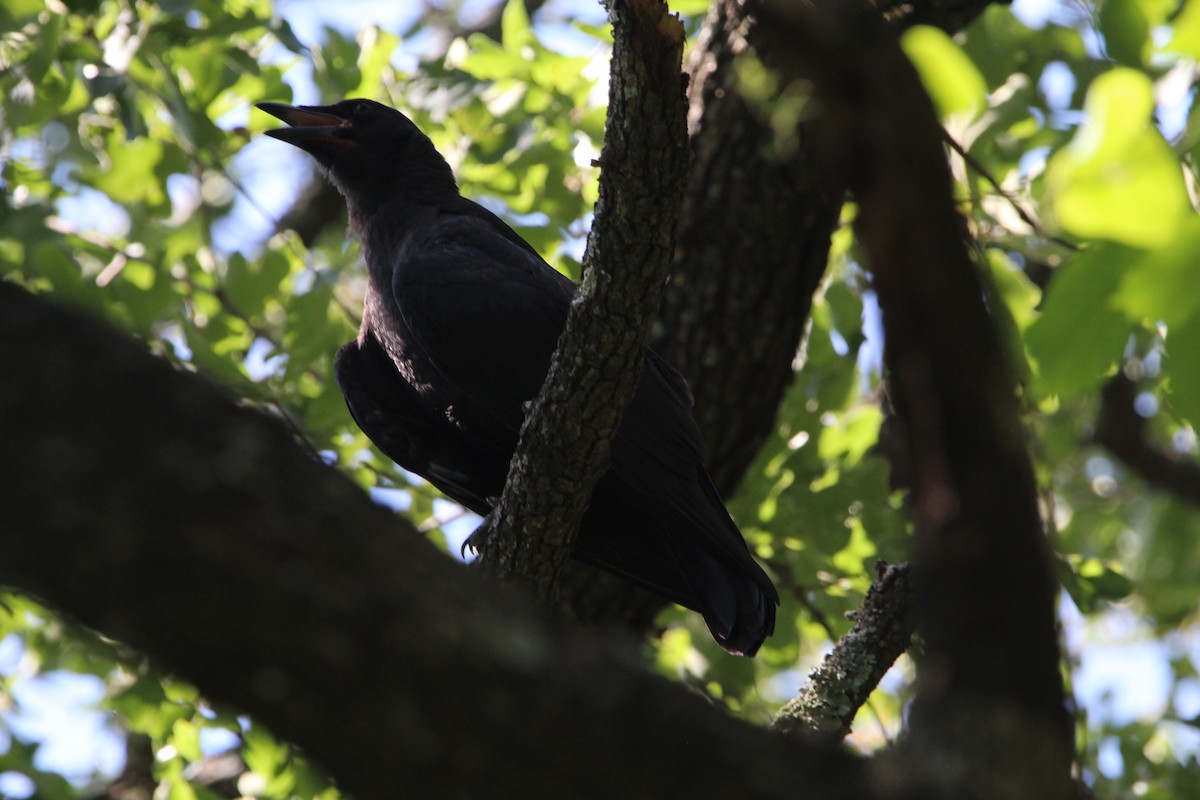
[762,2,1072,800]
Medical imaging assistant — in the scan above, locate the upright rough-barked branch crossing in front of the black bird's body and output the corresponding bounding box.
[476,0,689,599]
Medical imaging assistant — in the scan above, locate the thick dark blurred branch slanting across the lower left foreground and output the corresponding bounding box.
[0,283,872,800]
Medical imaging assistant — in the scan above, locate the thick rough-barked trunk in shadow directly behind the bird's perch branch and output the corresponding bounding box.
[654,0,842,493]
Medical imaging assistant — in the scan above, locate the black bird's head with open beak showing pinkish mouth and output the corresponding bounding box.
[258,98,457,219]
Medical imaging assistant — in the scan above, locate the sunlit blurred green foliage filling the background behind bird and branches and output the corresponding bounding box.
[0,0,1200,798]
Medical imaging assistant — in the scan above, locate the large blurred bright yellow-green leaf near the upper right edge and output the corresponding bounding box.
[1046,67,1192,247]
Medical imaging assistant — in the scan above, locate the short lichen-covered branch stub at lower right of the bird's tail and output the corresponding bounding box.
[773,563,917,741]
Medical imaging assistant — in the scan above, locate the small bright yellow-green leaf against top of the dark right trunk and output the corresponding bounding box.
[900,25,988,119]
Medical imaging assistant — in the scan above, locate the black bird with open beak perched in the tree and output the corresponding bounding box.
[258,100,779,655]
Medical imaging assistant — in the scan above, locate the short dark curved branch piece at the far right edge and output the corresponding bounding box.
[1092,373,1200,505]
